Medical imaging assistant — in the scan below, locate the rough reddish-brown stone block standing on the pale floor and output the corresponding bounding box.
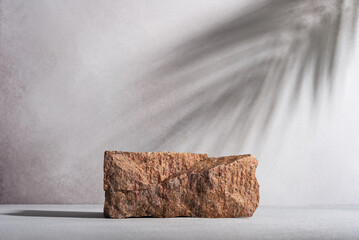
[104,151,259,218]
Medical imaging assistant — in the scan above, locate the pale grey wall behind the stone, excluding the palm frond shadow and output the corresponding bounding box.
[0,0,359,204]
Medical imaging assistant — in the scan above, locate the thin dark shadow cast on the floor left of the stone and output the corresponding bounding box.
[6,210,104,218]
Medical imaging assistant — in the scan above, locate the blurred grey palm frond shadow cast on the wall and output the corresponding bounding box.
[125,0,359,154]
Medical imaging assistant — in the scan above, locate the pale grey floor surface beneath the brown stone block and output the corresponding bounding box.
[0,205,359,240]
